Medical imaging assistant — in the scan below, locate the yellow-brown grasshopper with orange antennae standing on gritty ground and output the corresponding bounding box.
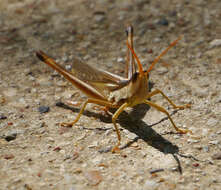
[36,26,191,152]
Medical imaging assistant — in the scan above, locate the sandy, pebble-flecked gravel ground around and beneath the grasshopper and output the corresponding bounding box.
[0,0,221,190]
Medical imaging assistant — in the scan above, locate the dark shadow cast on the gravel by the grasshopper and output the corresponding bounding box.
[56,98,182,174]
